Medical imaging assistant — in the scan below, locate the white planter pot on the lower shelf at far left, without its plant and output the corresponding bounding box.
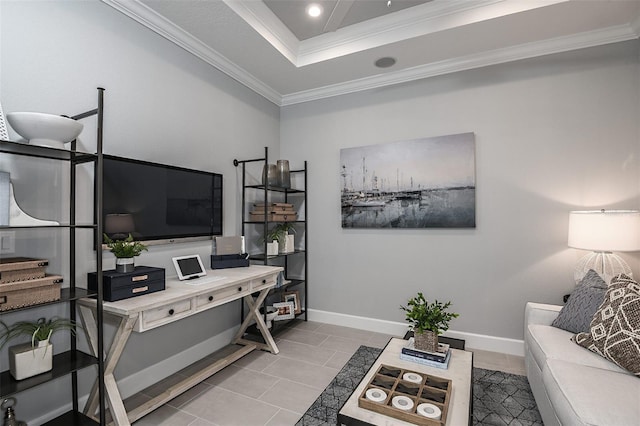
[9,341,53,380]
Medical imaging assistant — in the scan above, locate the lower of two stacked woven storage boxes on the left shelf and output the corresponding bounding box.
[0,275,62,311]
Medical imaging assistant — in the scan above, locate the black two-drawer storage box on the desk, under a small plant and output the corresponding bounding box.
[87,266,165,302]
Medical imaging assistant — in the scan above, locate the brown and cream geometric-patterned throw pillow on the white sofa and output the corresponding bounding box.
[574,274,640,376]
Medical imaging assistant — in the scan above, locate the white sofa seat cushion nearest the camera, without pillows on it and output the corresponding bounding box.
[542,359,640,426]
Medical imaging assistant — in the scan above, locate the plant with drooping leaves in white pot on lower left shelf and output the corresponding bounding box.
[0,317,79,380]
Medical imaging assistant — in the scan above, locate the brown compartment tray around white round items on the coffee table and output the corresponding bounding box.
[358,364,451,426]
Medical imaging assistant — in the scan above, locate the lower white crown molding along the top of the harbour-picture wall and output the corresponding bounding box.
[280,24,638,106]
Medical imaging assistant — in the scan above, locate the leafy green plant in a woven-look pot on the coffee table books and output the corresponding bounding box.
[400,292,459,352]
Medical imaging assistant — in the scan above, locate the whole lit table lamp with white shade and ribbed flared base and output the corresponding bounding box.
[568,209,640,284]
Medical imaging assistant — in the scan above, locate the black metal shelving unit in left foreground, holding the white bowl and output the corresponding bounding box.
[0,87,106,426]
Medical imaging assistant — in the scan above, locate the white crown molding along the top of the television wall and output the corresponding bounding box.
[101,0,282,105]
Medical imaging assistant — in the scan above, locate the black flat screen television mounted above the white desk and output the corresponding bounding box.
[102,155,222,241]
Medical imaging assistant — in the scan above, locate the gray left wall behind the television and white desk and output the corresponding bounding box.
[0,1,280,424]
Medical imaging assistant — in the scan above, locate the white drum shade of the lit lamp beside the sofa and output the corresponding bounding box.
[569,210,640,252]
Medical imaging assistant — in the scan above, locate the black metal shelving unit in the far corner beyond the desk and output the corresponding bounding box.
[233,147,309,336]
